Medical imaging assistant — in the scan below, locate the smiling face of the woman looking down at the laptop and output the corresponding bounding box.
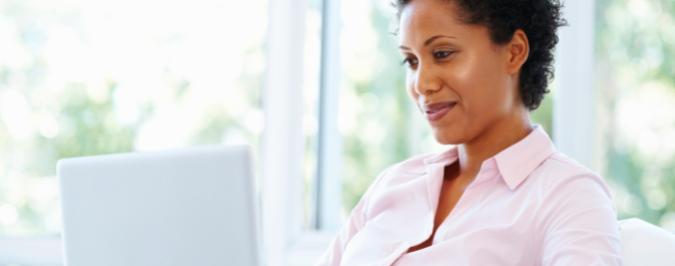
[399,0,524,144]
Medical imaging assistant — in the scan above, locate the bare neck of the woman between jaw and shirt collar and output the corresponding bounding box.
[458,111,532,178]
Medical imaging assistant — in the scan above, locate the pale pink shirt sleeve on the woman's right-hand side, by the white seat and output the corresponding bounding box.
[542,174,622,266]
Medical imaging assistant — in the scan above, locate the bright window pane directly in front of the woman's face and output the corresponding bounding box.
[339,0,422,213]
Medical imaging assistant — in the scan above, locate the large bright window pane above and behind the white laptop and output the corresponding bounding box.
[0,0,267,236]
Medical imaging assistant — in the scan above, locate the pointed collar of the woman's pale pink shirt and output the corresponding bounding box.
[423,125,555,190]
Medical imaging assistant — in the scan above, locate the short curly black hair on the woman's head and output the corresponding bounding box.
[394,0,567,111]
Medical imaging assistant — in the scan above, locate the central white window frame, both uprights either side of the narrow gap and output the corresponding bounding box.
[260,0,342,266]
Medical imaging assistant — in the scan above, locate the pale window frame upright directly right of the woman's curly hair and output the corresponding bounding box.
[553,0,599,169]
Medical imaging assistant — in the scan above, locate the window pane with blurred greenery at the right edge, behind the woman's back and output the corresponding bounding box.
[595,0,675,231]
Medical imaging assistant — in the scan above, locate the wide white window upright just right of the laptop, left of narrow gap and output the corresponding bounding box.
[257,0,308,266]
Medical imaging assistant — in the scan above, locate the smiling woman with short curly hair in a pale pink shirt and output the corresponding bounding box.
[319,0,621,265]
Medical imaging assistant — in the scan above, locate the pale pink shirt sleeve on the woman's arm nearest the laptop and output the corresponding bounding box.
[316,167,387,266]
